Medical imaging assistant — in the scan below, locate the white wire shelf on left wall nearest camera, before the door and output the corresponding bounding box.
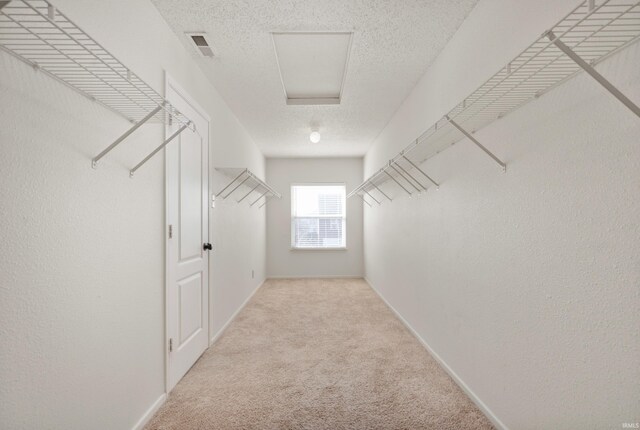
[0,0,196,177]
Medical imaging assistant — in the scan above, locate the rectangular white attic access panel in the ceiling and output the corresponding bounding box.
[271,32,352,105]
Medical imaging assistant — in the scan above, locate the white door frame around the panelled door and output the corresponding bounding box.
[164,70,212,394]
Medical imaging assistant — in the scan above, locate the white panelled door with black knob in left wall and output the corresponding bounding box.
[166,77,209,392]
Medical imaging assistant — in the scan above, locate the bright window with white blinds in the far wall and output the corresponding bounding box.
[291,184,347,249]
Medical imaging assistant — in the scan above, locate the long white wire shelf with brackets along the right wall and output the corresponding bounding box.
[347,0,640,207]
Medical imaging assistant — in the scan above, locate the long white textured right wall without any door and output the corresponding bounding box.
[364,0,640,429]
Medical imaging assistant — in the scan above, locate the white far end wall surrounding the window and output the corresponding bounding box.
[266,158,363,278]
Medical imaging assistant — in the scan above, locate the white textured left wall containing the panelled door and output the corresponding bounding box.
[0,0,265,429]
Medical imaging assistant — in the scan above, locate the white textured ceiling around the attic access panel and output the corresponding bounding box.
[152,0,477,157]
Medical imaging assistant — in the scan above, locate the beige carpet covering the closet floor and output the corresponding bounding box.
[145,279,493,430]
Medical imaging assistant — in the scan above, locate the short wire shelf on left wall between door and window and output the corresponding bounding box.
[215,167,282,209]
